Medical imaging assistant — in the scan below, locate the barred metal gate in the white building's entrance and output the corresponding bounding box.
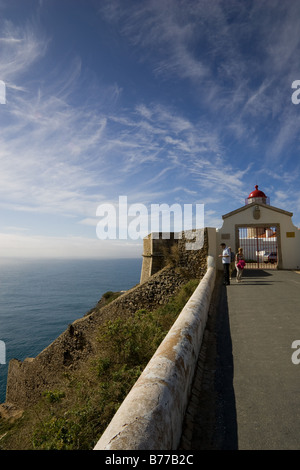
[238,226,278,269]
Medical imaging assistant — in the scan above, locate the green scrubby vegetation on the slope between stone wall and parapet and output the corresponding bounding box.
[0,280,199,450]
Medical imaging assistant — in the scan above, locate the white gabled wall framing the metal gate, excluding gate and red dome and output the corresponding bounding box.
[217,204,300,269]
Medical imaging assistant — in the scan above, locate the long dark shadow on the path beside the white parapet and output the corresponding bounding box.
[179,275,238,451]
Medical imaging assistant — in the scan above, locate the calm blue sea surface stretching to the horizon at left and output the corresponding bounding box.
[0,258,142,403]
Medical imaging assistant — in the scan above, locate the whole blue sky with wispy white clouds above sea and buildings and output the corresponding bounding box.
[0,0,300,258]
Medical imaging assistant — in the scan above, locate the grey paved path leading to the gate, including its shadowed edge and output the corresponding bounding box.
[180,270,300,450]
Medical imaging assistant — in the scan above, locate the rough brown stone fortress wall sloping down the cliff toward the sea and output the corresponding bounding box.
[6,231,208,408]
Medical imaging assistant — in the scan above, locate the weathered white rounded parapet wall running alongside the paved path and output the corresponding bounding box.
[94,257,216,450]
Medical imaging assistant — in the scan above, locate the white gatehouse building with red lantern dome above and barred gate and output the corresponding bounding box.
[217,185,300,269]
